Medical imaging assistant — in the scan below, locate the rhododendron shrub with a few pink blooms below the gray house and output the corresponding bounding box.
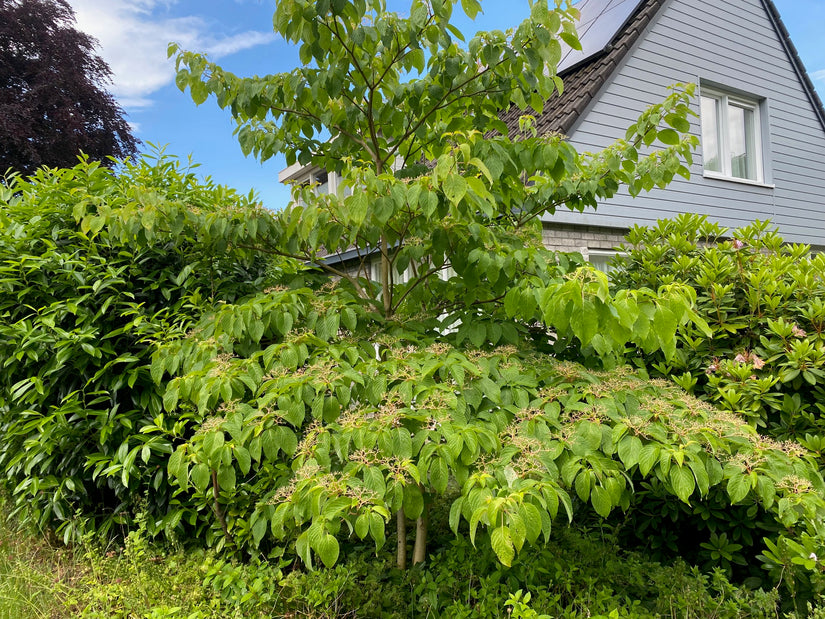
[612,215,825,444]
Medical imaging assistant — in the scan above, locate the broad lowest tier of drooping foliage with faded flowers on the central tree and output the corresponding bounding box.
[154,283,822,566]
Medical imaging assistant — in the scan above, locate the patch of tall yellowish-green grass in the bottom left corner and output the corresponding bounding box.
[0,505,225,619]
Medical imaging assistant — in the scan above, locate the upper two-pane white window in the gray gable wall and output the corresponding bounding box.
[701,88,764,183]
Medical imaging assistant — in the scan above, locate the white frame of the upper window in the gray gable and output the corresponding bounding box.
[699,86,767,185]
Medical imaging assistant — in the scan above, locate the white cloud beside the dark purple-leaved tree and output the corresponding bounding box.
[64,0,275,109]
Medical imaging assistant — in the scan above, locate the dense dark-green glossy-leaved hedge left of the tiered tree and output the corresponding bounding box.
[0,154,280,540]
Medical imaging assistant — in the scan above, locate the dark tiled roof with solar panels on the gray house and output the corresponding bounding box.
[502,0,825,134]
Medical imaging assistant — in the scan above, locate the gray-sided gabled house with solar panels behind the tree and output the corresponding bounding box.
[279,0,825,265]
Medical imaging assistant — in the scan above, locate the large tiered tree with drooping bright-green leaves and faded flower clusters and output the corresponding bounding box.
[153,0,821,567]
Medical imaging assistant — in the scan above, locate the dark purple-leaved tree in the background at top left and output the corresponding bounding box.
[0,0,137,174]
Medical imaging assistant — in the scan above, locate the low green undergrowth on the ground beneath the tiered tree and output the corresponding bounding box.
[272,527,779,619]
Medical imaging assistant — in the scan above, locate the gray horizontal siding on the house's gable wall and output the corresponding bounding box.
[548,0,825,245]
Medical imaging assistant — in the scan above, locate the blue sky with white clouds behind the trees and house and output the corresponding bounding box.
[68,0,825,208]
